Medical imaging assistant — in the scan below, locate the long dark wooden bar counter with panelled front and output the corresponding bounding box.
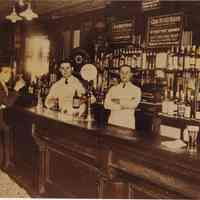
[1,107,200,199]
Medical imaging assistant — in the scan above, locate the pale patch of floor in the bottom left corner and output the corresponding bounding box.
[0,170,30,198]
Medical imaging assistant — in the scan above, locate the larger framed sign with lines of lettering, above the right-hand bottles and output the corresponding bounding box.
[147,13,183,47]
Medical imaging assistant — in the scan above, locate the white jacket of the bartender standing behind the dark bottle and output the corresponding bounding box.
[45,75,85,114]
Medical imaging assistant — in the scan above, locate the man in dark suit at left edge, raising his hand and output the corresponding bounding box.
[0,66,25,166]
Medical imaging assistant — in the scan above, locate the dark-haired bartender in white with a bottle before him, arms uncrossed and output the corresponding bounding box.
[45,61,85,115]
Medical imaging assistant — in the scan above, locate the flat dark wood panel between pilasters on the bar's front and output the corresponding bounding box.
[46,148,99,198]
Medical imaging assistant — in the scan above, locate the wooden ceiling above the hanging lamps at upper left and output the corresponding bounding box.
[0,0,107,21]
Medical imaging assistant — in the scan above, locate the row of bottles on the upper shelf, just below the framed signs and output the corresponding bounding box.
[95,45,200,70]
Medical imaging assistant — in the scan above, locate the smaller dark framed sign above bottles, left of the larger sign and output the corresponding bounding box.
[111,18,135,44]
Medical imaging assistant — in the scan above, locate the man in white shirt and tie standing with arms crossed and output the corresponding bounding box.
[104,65,141,129]
